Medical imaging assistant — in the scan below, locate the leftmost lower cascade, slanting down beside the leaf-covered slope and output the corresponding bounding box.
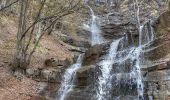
[56,54,84,100]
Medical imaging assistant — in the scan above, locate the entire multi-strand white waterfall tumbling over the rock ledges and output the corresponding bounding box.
[56,0,154,100]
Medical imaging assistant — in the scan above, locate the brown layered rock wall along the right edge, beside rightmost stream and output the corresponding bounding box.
[142,11,170,100]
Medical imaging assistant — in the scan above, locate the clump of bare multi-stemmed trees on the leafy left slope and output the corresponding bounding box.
[13,0,81,70]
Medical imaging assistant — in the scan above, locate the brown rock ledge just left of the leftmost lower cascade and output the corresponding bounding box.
[25,58,73,83]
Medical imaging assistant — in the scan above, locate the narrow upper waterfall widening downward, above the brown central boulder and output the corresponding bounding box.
[88,6,104,46]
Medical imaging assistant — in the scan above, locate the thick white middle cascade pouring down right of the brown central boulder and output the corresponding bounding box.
[97,39,121,100]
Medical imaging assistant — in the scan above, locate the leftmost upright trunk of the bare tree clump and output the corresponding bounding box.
[14,0,28,69]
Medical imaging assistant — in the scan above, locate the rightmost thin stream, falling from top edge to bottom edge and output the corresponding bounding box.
[131,0,154,100]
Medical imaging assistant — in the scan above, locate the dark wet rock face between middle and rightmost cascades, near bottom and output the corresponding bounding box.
[112,73,137,96]
